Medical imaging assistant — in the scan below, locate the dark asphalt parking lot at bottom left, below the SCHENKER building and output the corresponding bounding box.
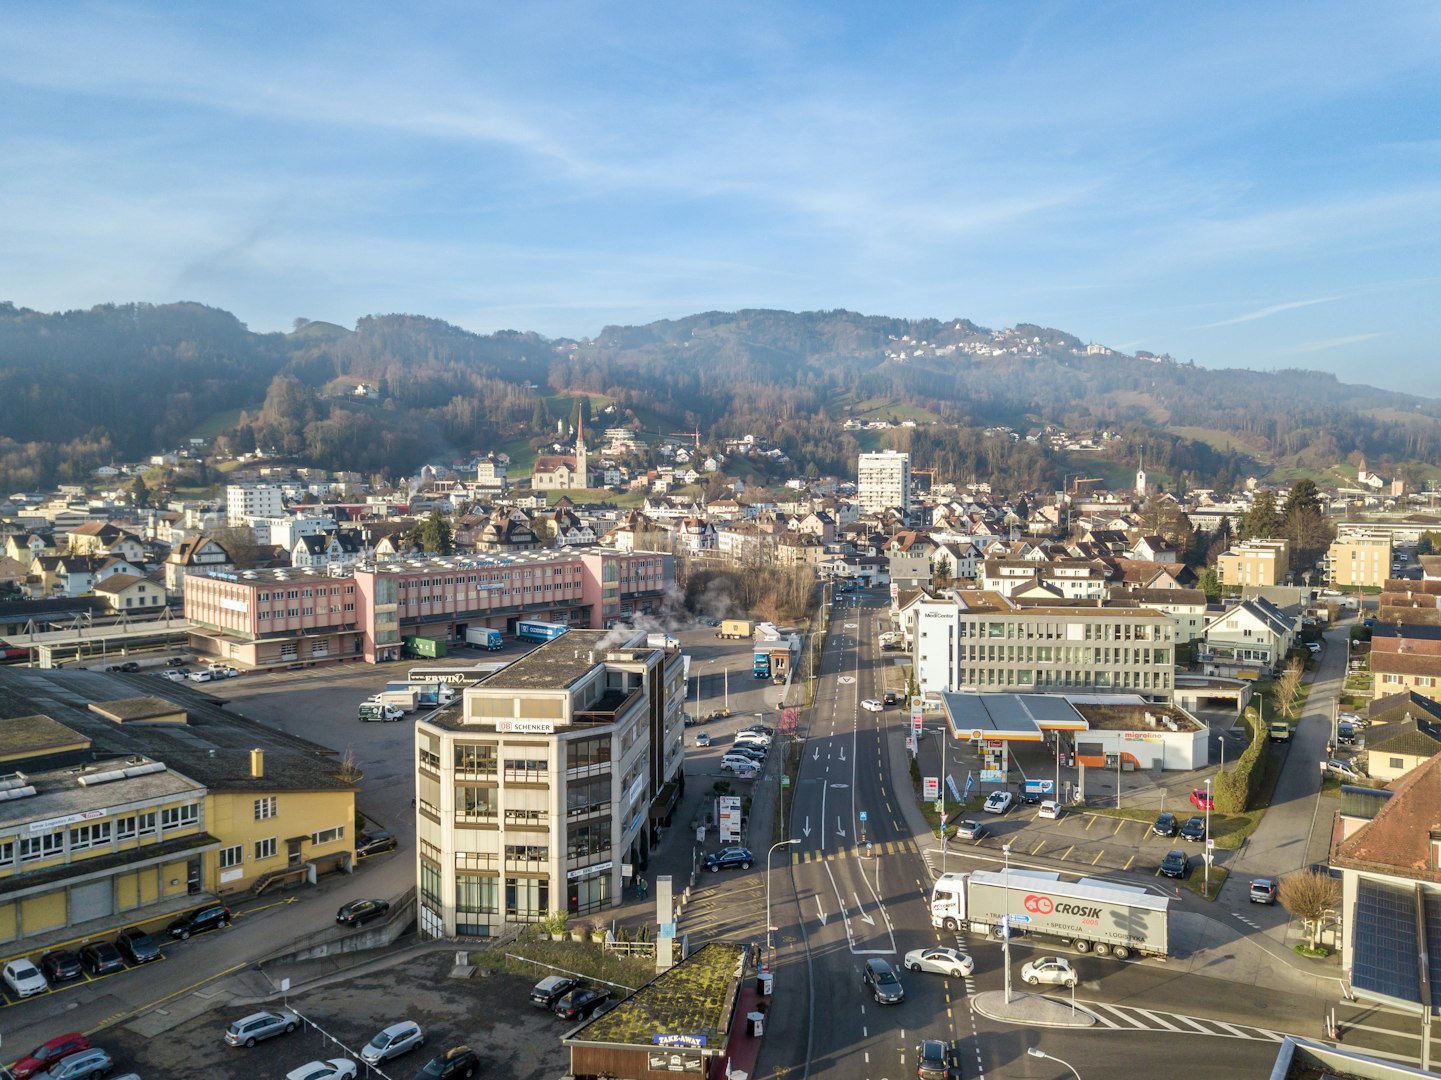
[92,952,572,1080]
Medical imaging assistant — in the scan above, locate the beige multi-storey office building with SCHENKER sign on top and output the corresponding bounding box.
[415,630,684,937]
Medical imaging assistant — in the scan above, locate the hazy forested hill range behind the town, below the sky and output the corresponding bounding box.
[0,303,1441,490]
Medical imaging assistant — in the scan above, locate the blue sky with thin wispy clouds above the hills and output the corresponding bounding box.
[8,0,1441,397]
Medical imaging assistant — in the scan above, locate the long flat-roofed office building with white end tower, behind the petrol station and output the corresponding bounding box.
[911,593,1176,701]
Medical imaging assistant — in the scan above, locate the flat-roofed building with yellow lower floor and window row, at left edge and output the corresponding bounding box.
[0,717,219,942]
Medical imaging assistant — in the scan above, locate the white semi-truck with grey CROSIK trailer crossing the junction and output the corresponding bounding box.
[931,869,1170,960]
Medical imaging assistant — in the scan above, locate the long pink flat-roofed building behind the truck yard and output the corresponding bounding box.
[184,549,674,668]
